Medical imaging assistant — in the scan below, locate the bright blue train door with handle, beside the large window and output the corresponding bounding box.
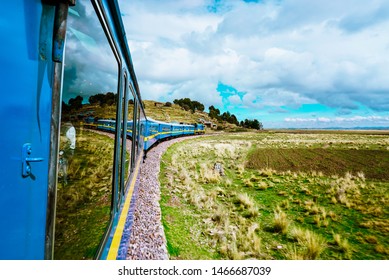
[0,0,55,259]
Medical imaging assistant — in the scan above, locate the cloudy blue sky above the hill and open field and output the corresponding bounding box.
[119,0,389,128]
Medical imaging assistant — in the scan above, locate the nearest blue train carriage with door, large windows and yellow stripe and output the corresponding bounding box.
[0,0,146,259]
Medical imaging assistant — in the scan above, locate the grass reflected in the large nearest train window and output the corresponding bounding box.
[54,129,114,260]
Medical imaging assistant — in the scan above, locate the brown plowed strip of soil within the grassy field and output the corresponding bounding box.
[247,148,389,181]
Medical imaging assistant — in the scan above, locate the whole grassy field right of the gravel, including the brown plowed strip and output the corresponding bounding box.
[160,132,389,259]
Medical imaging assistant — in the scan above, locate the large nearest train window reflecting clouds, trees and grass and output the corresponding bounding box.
[54,1,119,259]
